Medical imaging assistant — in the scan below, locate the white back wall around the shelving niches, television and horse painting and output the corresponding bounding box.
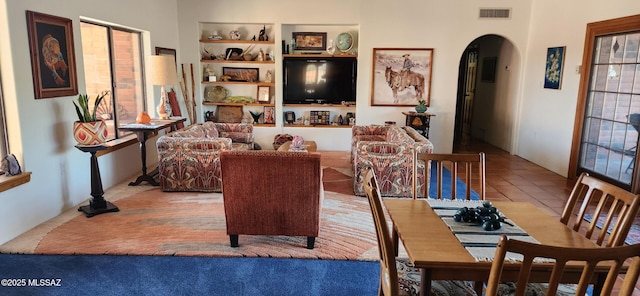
[178,0,531,152]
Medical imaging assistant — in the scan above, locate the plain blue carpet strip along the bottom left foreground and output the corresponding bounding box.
[0,254,380,296]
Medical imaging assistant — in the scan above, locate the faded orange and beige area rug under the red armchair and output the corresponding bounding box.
[6,188,378,261]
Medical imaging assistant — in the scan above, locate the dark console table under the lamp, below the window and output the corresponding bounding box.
[118,117,187,186]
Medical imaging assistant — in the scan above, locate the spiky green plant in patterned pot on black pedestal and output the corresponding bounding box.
[73,91,109,145]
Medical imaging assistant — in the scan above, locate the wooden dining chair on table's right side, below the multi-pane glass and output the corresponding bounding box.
[560,173,640,247]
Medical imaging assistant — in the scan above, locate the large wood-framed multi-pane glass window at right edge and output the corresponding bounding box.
[569,16,640,192]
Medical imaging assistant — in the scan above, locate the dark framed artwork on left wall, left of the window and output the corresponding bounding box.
[27,10,78,99]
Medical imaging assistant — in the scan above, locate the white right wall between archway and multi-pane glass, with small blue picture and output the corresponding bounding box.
[514,0,640,176]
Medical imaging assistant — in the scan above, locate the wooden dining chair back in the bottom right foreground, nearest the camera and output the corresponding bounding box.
[486,234,640,296]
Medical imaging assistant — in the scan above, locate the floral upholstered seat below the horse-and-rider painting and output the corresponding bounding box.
[351,125,433,197]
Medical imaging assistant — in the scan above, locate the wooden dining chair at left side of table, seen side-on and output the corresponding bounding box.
[364,169,477,296]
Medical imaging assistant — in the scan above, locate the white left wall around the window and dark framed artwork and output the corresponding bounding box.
[0,0,178,244]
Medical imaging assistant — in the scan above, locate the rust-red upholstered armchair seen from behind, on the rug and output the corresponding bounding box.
[220,150,323,249]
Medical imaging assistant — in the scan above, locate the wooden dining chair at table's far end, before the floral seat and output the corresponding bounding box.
[413,152,486,200]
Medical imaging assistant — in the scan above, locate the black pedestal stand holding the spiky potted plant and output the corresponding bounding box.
[76,145,120,218]
